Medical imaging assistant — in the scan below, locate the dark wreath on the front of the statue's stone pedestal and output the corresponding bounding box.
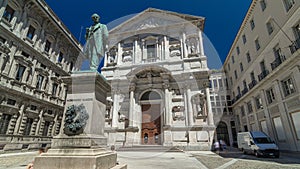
[64,104,89,136]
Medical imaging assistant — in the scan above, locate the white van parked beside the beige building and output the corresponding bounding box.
[237,131,279,158]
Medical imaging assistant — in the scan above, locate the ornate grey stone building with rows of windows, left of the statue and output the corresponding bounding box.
[0,0,81,150]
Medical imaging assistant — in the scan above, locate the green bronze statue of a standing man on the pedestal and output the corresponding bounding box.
[84,14,108,71]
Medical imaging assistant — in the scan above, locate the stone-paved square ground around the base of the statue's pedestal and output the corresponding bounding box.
[0,149,300,169]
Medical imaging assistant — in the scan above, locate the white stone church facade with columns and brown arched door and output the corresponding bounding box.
[102,8,215,150]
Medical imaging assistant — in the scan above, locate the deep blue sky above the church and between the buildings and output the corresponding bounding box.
[45,0,251,68]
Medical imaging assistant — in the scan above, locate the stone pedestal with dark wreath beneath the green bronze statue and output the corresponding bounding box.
[34,72,126,169]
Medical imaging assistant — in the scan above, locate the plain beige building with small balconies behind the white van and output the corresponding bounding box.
[223,0,300,151]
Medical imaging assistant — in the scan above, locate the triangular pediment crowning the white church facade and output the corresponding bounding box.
[110,8,204,34]
